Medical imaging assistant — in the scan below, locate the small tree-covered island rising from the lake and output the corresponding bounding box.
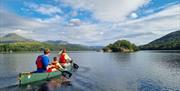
[103,40,138,52]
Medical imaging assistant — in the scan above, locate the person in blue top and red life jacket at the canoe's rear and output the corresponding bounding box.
[35,49,50,73]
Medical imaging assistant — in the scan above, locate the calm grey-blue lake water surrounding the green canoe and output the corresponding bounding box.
[0,51,180,91]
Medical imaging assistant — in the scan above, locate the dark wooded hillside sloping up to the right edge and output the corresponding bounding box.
[139,30,180,50]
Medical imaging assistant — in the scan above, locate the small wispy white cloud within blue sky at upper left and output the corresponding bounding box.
[26,3,63,15]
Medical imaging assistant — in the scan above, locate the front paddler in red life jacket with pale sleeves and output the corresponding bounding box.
[59,49,72,67]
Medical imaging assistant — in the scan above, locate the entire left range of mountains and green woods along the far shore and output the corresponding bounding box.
[0,33,93,52]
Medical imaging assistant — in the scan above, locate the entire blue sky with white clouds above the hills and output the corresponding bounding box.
[0,0,180,46]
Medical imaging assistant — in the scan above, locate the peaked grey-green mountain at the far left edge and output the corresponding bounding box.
[0,33,33,43]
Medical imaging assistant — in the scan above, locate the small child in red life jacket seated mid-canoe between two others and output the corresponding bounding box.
[47,57,63,72]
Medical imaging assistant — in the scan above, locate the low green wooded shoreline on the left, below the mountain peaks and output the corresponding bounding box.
[0,42,90,52]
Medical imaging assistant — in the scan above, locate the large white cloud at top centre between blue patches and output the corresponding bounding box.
[63,0,150,22]
